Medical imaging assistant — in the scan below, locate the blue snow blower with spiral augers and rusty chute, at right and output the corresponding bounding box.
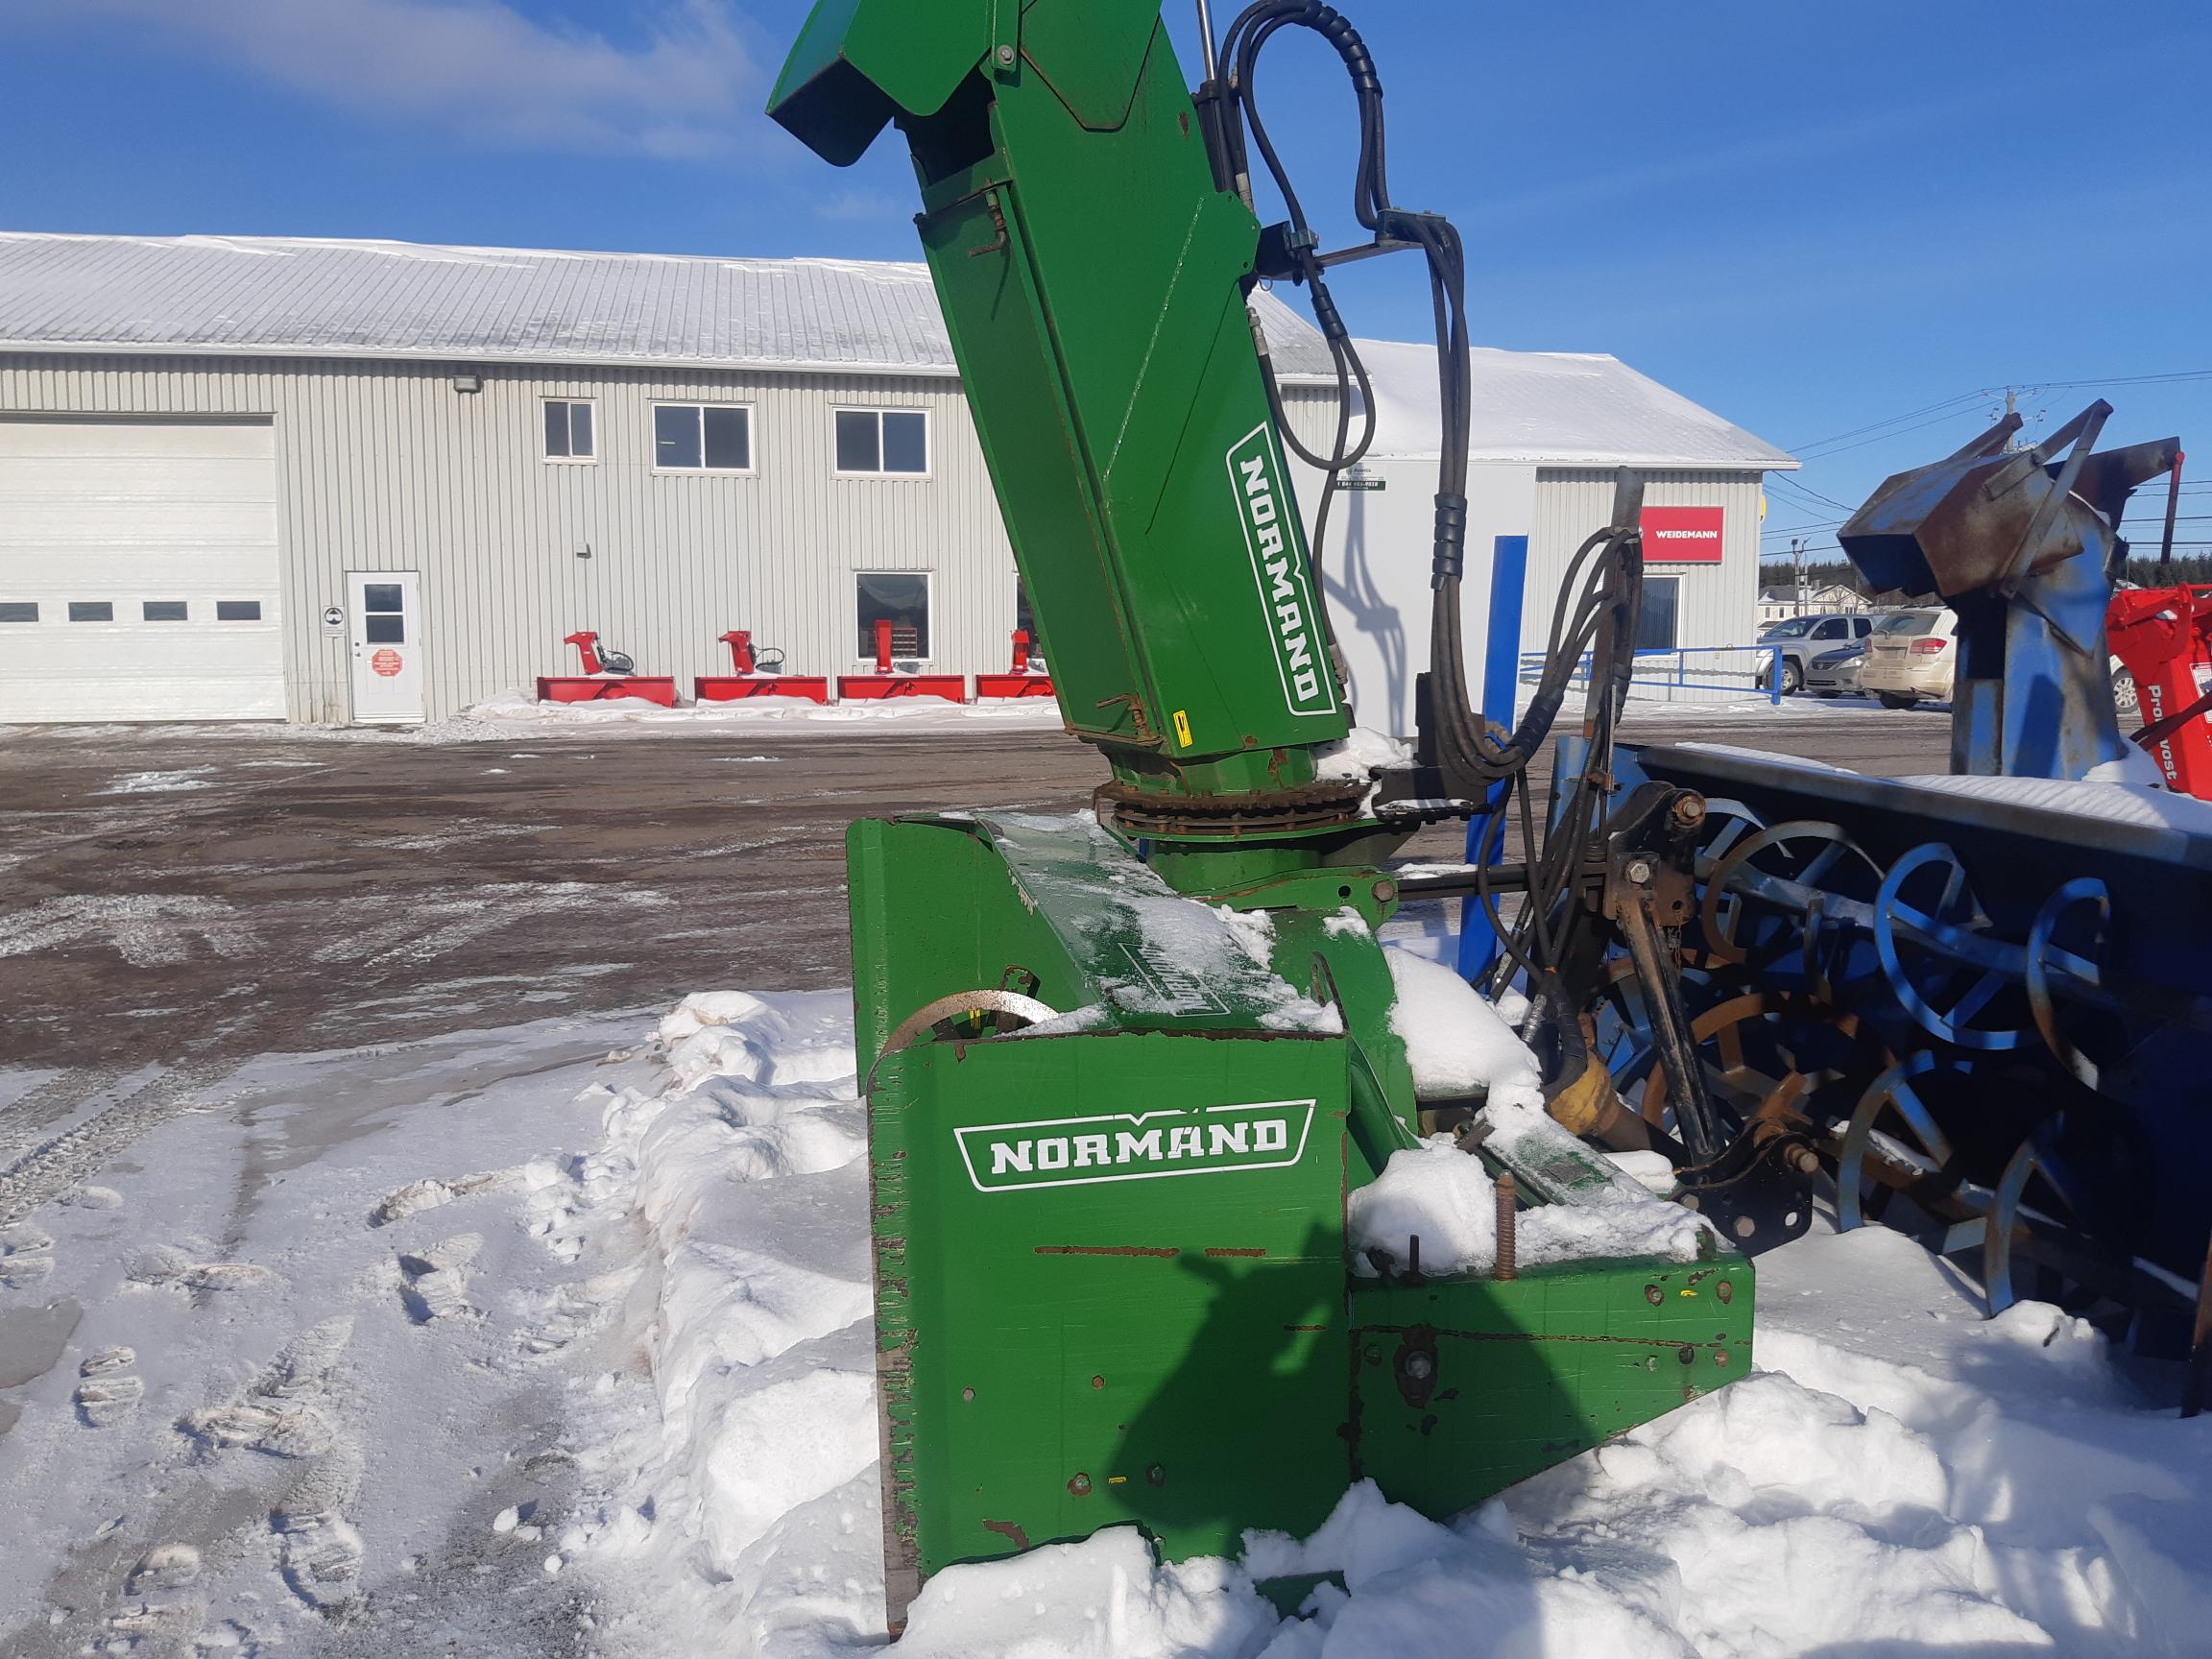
[1557,402,2212,1388]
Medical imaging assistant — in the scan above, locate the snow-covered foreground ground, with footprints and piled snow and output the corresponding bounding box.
[0,973,2212,1659]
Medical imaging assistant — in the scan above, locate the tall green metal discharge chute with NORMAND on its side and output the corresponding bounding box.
[770,0,1347,794]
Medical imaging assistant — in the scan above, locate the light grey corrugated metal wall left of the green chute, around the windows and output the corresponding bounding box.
[0,356,1016,721]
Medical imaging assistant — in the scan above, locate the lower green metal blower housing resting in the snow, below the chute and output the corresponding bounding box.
[847,814,1752,1610]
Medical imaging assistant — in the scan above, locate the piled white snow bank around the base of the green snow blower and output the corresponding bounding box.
[548,993,2212,1659]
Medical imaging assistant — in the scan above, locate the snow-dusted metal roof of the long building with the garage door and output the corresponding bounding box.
[0,232,1330,380]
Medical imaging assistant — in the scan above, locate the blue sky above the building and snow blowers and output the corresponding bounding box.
[0,0,2212,565]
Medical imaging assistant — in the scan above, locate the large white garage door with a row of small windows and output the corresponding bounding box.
[0,418,285,721]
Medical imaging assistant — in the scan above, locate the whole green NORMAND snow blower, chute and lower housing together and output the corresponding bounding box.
[770,0,1752,1628]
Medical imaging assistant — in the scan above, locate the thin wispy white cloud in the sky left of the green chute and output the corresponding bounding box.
[46,0,763,157]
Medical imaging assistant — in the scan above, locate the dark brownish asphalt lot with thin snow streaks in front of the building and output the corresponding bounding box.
[0,708,1949,1221]
